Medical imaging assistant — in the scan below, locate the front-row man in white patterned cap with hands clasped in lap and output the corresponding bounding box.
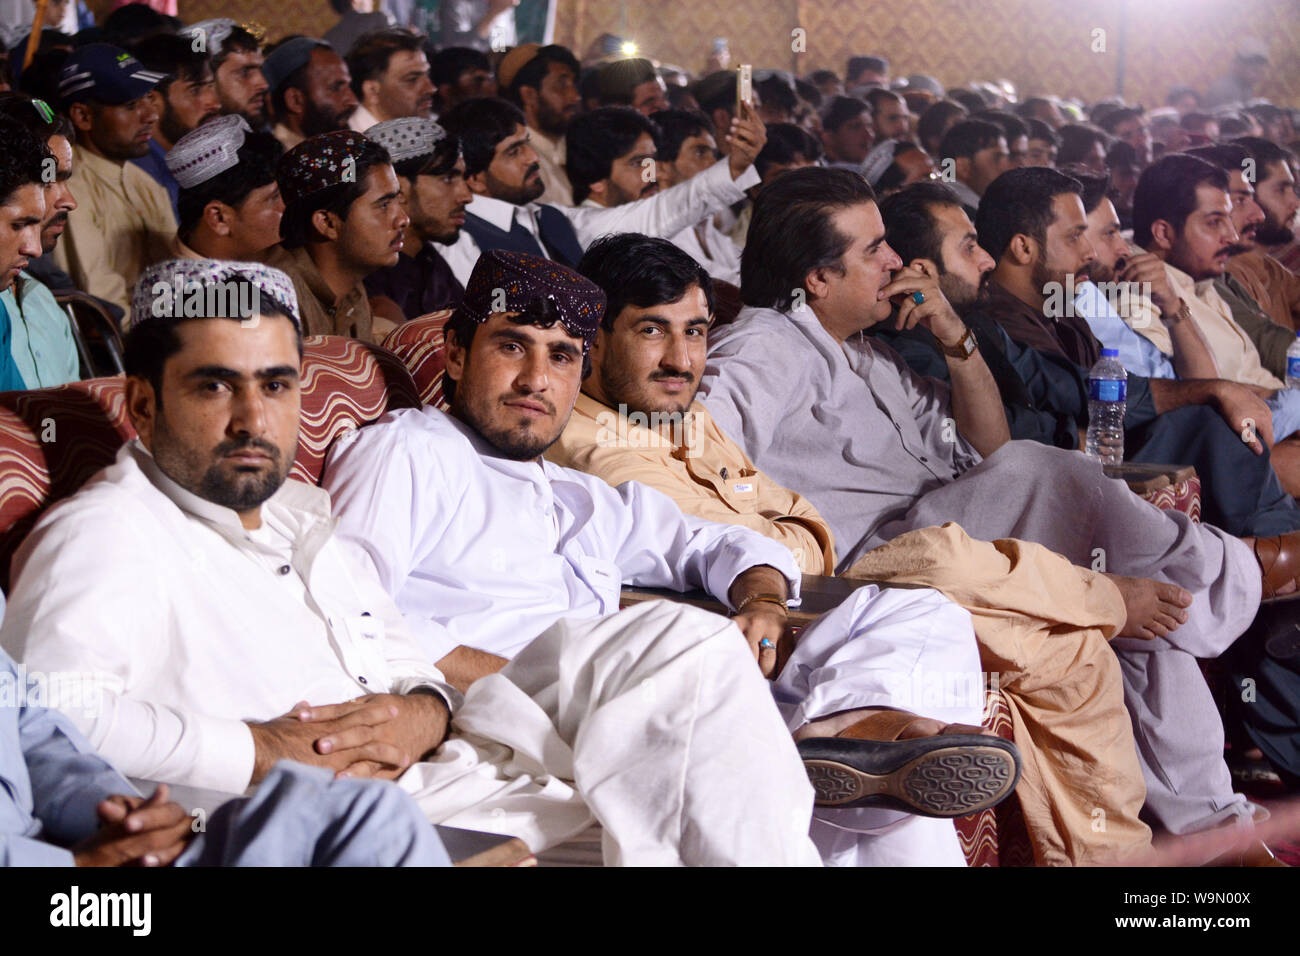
[0,254,816,865]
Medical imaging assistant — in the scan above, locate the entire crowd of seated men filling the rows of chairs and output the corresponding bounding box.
[0,3,1300,866]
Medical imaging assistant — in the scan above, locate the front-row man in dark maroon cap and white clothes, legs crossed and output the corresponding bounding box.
[322,250,1017,865]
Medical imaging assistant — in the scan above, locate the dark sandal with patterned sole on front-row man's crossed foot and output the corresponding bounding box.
[798,734,1021,817]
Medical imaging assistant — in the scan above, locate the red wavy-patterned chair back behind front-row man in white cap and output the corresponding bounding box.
[0,336,420,589]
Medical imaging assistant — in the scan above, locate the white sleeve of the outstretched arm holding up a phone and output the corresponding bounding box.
[554,159,759,248]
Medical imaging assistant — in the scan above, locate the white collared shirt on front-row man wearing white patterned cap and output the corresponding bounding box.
[0,441,459,793]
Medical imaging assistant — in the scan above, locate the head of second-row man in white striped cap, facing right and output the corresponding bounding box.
[166,114,285,261]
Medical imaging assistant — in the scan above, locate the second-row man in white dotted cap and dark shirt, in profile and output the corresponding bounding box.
[365,117,473,321]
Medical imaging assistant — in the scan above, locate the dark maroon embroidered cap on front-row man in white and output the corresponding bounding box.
[456,248,605,355]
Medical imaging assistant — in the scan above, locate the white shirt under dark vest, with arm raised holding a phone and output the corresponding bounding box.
[438,159,759,285]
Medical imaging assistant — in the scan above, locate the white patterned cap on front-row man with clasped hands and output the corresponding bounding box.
[131,259,302,330]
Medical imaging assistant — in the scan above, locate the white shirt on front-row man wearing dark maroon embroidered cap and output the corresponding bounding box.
[324,407,800,661]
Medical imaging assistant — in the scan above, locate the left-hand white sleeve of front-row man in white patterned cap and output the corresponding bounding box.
[0,501,254,793]
